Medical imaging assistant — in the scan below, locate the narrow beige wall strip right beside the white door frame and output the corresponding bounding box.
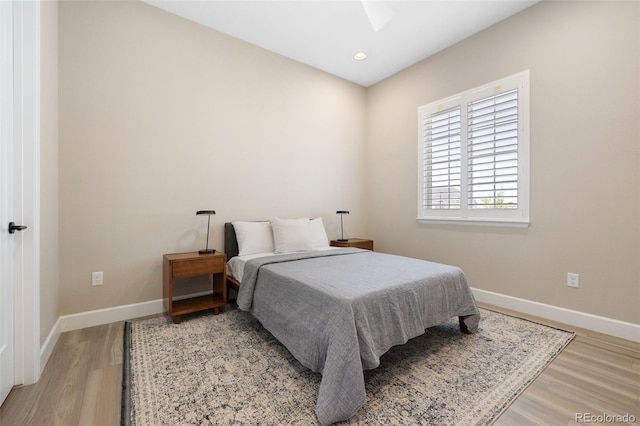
[40,2,59,344]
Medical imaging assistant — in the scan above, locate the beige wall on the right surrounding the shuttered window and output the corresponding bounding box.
[366,1,640,323]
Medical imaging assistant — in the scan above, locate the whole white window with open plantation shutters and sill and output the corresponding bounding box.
[418,71,529,226]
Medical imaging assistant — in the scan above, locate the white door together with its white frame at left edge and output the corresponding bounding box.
[0,0,40,403]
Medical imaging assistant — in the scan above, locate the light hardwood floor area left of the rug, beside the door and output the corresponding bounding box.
[0,322,124,426]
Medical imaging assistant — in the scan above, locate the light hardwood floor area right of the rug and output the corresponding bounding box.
[486,306,640,426]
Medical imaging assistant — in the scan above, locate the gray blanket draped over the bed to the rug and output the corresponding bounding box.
[237,249,480,425]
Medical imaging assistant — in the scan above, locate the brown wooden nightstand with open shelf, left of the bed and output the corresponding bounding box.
[162,251,227,324]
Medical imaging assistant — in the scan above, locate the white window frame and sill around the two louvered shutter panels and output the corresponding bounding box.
[417,70,530,227]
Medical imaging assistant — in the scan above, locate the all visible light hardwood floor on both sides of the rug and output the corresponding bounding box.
[0,306,640,426]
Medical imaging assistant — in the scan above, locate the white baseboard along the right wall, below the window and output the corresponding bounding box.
[472,288,640,343]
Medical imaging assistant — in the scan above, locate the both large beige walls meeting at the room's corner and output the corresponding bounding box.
[56,1,640,330]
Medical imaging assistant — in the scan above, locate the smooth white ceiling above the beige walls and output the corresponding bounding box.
[143,0,539,87]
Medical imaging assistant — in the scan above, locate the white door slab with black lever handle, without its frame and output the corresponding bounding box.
[0,2,20,403]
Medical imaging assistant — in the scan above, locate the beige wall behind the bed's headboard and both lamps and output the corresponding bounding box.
[59,2,366,315]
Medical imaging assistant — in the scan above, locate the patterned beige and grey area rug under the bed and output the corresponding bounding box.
[122,306,573,426]
